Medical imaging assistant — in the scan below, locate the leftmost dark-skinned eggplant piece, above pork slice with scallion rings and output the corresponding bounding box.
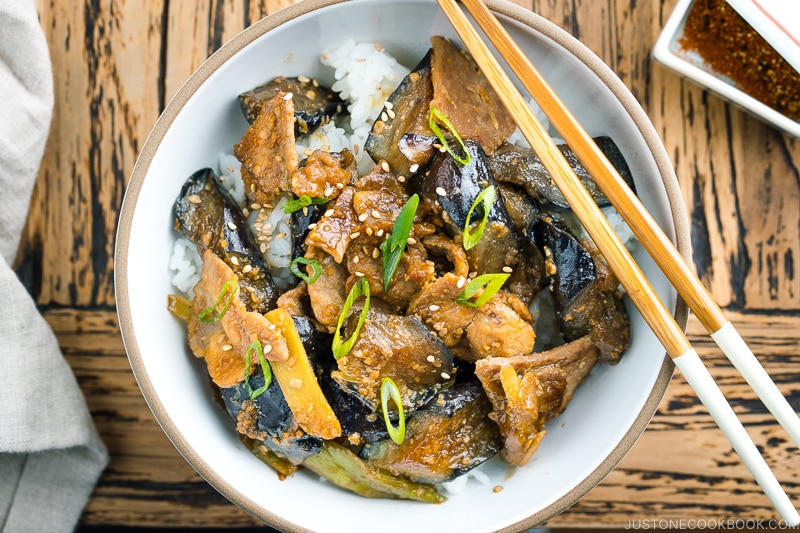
[175,168,279,313]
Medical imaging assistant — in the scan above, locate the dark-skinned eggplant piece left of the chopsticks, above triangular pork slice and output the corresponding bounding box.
[529,215,630,364]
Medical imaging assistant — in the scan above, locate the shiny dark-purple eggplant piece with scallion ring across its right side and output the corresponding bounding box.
[422,139,521,274]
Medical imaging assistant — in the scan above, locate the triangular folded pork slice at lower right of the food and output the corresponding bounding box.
[475,338,599,466]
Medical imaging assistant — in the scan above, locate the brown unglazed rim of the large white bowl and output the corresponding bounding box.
[115,0,691,532]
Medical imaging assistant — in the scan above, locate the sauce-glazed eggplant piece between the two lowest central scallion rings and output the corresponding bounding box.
[332,299,455,414]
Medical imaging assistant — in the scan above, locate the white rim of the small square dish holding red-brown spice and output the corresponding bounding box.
[653,0,800,137]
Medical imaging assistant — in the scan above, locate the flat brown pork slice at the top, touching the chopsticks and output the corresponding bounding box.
[431,37,517,152]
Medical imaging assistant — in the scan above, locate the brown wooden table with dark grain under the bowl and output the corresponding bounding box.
[16,0,800,527]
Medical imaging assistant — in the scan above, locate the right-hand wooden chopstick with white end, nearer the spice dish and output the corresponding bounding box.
[456,0,800,458]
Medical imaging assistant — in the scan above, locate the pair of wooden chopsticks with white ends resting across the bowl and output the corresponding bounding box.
[437,0,800,526]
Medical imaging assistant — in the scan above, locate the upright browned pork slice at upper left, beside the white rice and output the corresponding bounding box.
[233,92,298,205]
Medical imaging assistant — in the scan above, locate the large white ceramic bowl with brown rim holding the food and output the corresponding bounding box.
[116,0,689,533]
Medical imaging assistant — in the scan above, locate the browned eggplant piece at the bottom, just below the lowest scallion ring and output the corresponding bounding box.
[361,378,502,483]
